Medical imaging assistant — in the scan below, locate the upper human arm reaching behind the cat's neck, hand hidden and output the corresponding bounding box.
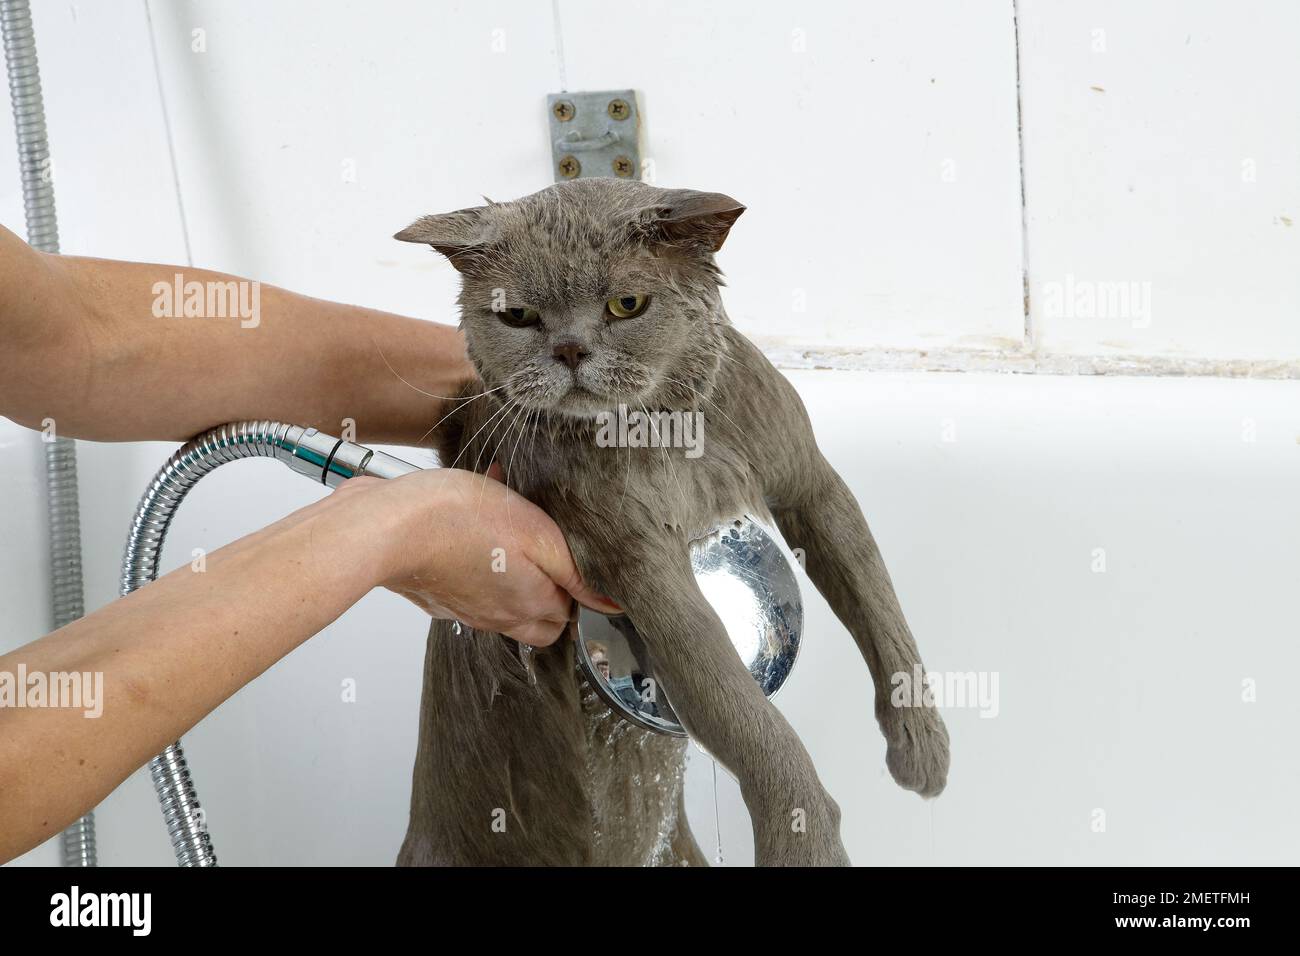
[0,228,475,445]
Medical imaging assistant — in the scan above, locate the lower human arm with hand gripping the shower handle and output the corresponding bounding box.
[0,470,616,862]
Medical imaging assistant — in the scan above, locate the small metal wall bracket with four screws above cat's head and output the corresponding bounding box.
[546,90,642,182]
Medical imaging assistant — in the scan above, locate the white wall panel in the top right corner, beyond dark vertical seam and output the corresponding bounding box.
[1019,0,1300,362]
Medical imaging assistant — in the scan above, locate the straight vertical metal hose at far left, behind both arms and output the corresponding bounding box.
[0,0,98,866]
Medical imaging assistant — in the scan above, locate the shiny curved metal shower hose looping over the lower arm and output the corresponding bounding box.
[121,421,417,866]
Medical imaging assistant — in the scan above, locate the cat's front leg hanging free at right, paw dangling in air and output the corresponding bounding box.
[771,460,949,797]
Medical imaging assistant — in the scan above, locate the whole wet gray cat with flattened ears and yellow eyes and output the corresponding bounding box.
[397,179,948,865]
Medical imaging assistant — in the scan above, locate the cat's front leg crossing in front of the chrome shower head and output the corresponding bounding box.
[568,529,849,866]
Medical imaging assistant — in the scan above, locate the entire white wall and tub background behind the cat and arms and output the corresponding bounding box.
[0,0,1300,864]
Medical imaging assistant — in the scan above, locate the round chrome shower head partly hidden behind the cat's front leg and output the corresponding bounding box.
[577,516,803,737]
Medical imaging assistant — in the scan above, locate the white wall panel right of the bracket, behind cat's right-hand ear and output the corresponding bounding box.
[560,0,1024,349]
